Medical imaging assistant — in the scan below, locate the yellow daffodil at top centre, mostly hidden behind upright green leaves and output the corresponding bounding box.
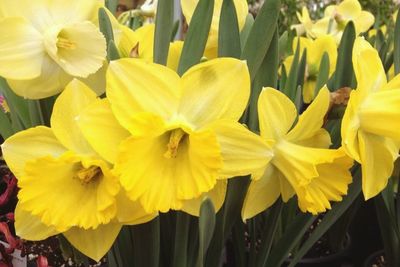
[181,0,249,59]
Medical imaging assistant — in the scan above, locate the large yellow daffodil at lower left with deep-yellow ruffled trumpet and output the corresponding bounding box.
[2,80,155,260]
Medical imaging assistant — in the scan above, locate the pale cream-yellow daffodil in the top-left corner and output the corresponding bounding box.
[0,0,106,99]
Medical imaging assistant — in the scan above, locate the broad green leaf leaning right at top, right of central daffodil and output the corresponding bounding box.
[241,0,281,80]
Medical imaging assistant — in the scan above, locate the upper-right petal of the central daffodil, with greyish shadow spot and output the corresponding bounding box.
[179,58,250,128]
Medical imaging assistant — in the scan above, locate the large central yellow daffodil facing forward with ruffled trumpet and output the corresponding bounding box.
[79,58,271,213]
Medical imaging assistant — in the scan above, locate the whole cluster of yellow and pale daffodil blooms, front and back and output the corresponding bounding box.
[0,0,400,260]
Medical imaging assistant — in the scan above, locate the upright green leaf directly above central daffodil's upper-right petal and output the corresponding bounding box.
[218,0,241,58]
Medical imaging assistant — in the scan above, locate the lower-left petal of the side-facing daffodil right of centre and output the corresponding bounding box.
[242,165,281,221]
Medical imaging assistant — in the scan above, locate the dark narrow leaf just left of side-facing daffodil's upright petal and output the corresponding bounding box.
[247,30,279,132]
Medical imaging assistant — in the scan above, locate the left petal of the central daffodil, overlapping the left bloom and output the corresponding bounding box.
[77,99,129,163]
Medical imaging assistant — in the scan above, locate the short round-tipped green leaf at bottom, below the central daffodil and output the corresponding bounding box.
[197,198,215,267]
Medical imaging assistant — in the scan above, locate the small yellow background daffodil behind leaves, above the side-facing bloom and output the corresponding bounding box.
[284,35,337,103]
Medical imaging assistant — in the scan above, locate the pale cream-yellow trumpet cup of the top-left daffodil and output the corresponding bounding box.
[44,21,106,78]
